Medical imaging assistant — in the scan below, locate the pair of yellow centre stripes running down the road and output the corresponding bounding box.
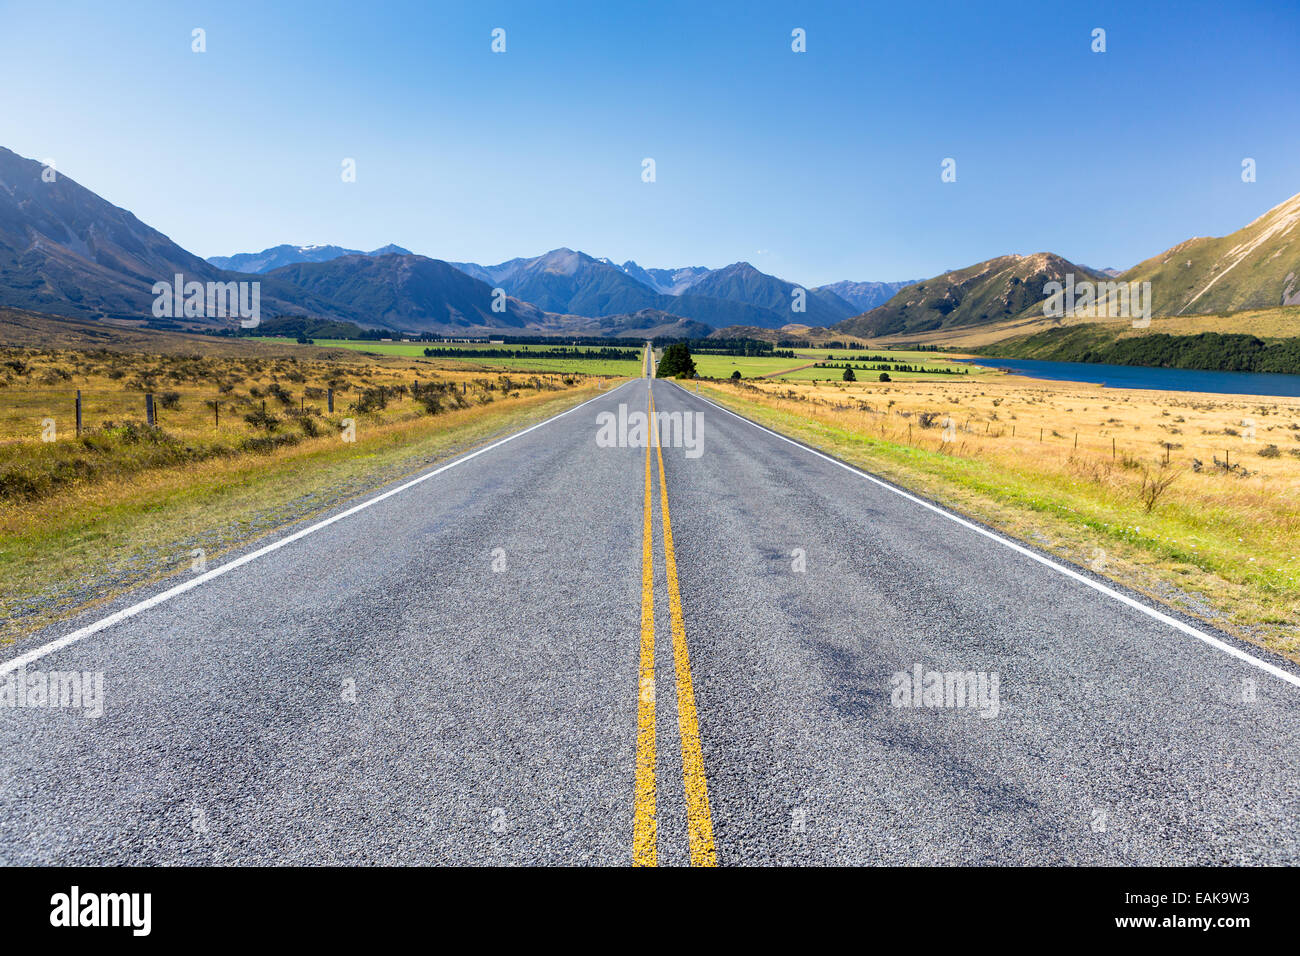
[632,393,718,866]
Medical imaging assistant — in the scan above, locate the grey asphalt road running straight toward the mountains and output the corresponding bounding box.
[0,380,1300,865]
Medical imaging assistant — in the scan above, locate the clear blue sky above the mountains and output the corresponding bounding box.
[0,0,1300,285]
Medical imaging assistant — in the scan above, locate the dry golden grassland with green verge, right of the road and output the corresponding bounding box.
[705,376,1300,659]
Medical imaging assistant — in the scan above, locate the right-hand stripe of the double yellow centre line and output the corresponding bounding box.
[655,385,718,866]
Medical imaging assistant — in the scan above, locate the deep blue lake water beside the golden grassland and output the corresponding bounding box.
[959,359,1300,397]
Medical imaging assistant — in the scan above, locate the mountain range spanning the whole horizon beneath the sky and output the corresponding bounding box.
[0,147,1300,337]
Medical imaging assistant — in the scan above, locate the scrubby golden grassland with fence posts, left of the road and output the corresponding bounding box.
[0,336,611,641]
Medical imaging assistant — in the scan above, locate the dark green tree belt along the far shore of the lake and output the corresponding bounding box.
[985,329,1300,375]
